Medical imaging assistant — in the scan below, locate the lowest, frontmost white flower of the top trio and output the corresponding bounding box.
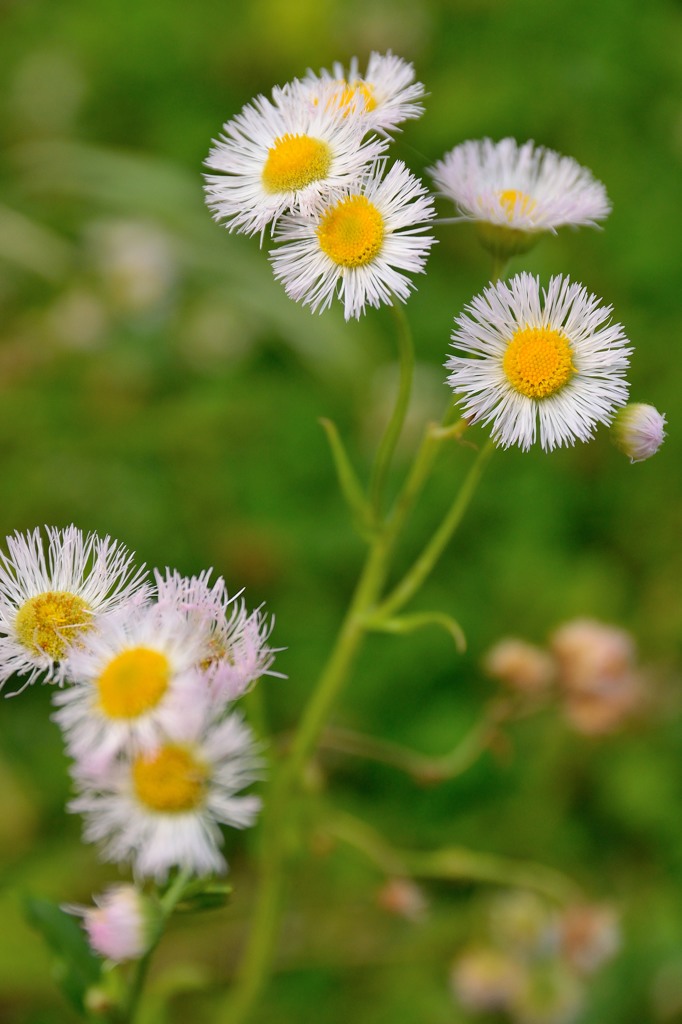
[270,161,434,319]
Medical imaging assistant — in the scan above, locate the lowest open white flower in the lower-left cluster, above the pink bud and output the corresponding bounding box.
[70,715,260,881]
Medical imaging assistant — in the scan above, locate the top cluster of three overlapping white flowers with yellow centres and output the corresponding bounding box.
[206,52,435,319]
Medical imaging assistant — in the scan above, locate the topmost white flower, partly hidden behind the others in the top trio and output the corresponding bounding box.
[303,50,424,134]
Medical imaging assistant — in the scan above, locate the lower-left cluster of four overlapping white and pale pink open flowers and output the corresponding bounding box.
[0,525,274,880]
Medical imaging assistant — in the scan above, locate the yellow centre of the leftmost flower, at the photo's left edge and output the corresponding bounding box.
[14,590,92,660]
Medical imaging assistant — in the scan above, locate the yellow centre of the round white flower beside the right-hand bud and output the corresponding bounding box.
[502,327,576,398]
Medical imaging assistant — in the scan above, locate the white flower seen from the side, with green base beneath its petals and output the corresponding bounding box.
[430,138,611,257]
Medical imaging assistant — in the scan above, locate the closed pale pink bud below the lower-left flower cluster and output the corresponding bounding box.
[74,884,161,964]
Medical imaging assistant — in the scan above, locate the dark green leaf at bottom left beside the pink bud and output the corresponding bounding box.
[24,896,102,1012]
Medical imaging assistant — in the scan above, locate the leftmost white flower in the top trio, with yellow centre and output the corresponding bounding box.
[206,82,386,236]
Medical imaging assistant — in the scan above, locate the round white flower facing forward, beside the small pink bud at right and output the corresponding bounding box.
[445,273,632,452]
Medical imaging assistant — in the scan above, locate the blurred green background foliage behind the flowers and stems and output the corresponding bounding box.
[0,0,682,1024]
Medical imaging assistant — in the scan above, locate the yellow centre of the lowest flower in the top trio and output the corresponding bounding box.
[317,196,384,267]
